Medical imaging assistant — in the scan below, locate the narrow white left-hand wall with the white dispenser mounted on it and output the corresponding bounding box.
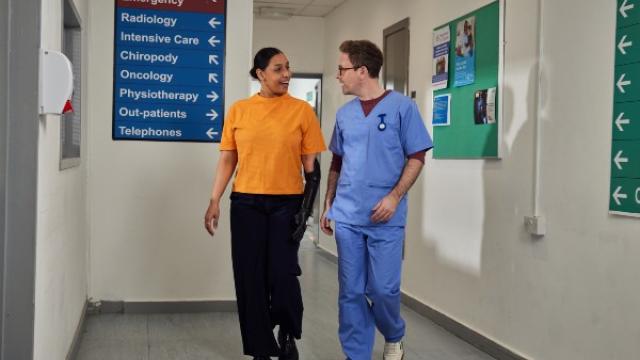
[34,0,89,359]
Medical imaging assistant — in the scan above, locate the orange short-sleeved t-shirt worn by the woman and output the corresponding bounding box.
[220,94,327,195]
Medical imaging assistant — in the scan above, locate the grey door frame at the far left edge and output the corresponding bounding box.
[0,0,41,360]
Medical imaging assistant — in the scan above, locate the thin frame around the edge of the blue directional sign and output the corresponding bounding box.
[111,0,231,144]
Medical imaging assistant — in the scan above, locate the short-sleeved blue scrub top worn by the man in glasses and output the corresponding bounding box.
[327,91,433,226]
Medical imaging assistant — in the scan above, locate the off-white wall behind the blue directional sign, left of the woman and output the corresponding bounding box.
[88,0,253,301]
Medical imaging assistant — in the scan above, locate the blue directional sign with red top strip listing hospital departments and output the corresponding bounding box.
[112,0,226,142]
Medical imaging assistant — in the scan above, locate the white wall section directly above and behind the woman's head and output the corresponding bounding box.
[251,16,324,74]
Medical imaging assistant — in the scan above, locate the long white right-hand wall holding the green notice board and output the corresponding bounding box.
[321,0,640,359]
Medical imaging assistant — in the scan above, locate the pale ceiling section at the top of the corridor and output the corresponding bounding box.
[253,0,346,19]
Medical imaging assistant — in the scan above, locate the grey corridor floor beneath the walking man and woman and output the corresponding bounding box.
[78,242,492,360]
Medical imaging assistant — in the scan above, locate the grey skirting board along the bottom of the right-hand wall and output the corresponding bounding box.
[318,247,527,360]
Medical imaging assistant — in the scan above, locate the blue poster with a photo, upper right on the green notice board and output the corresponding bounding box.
[454,16,476,87]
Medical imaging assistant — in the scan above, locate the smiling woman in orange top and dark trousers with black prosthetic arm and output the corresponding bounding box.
[205,48,326,360]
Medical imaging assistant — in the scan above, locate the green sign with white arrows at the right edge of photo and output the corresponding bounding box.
[609,0,640,216]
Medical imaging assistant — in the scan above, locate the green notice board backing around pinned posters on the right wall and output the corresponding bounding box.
[433,1,501,159]
